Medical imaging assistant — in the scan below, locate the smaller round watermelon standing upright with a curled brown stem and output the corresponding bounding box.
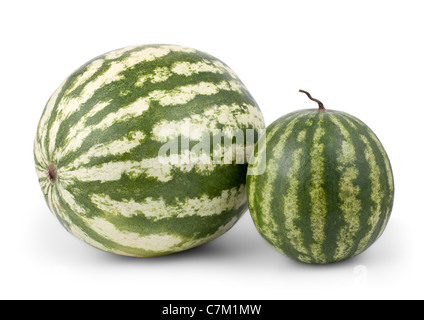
[247,90,394,264]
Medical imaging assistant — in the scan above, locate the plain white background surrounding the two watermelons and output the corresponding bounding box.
[0,0,424,299]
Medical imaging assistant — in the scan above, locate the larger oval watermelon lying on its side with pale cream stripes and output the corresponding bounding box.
[34,45,264,256]
